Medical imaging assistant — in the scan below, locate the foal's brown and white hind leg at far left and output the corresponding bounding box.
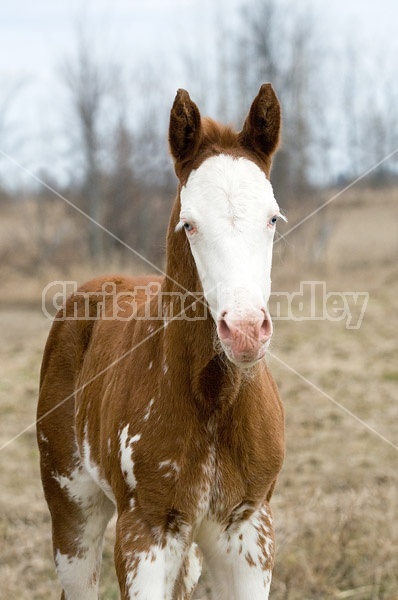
[46,466,114,600]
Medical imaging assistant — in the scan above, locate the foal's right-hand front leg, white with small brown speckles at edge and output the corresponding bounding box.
[198,503,274,600]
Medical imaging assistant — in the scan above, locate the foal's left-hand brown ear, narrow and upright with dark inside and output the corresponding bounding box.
[169,89,201,170]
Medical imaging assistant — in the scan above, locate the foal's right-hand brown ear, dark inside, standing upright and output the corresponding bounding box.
[239,83,281,167]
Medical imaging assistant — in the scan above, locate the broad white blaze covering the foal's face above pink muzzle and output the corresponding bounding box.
[180,154,279,320]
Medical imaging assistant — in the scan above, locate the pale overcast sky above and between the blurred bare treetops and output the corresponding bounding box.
[0,0,398,188]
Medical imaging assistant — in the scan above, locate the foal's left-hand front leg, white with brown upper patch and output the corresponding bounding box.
[115,504,194,600]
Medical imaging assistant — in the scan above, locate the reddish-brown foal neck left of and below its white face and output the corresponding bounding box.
[161,193,242,406]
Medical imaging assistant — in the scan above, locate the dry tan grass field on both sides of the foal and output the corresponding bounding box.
[0,190,398,600]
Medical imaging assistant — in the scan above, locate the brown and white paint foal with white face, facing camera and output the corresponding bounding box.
[38,84,284,600]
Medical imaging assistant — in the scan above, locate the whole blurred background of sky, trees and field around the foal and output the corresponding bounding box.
[0,0,398,600]
